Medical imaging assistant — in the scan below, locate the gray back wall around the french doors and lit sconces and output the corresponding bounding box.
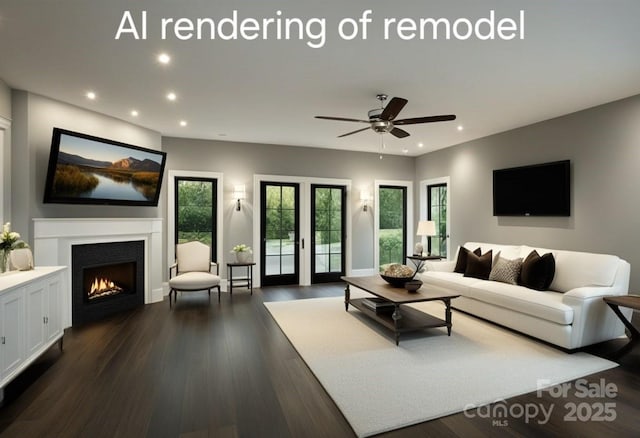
[162,138,415,269]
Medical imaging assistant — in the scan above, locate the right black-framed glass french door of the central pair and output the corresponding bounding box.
[311,184,347,283]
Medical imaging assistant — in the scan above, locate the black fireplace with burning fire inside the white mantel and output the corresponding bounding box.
[71,240,145,325]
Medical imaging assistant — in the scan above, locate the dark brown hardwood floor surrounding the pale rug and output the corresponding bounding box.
[0,284,640,438]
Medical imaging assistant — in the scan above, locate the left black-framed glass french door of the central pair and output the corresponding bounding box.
[260,181,300,286]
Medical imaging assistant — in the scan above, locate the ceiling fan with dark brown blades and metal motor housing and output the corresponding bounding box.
[316,94,456,138]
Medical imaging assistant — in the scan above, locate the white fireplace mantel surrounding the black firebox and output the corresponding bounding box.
[33,218,165,327]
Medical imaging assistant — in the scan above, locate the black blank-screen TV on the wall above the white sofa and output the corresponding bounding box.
[493,160,571,216]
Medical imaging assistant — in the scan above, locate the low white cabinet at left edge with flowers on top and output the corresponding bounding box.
[0,266,67,400]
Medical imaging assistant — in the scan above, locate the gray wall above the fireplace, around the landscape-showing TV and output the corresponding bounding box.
[11,90,164,243]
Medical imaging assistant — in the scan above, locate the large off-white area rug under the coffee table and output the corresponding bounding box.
[265,292,617,436]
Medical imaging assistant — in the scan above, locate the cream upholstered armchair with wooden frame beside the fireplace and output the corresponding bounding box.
[169,241,220,307]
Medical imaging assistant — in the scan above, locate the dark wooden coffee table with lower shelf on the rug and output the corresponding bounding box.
[341,275,460,345]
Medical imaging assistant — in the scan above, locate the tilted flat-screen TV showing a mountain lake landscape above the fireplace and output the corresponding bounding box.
[44,128,166,206]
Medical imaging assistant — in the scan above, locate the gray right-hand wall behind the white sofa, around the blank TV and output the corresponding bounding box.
[416,96,640,292]
